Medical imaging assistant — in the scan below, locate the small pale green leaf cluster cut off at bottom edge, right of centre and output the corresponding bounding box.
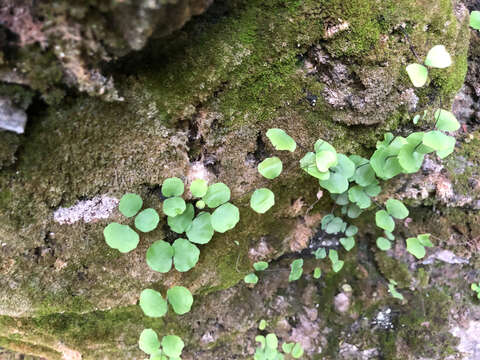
[253,333,303,360]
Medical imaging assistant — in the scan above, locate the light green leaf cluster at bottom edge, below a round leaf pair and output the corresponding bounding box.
[138,329,185,360]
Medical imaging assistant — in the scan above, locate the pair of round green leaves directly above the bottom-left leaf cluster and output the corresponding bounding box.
[140,286,193,318]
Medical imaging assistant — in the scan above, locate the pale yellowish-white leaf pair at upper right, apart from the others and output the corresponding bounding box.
[406,45,452,87]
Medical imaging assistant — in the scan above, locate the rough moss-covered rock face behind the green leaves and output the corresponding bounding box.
[0,0,480,360]
